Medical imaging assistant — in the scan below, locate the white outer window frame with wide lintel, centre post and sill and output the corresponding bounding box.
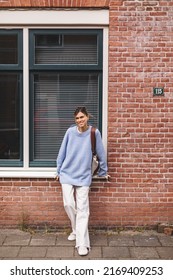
[0,10,109,178]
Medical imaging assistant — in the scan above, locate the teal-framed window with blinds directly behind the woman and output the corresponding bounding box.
[30,29,103,167]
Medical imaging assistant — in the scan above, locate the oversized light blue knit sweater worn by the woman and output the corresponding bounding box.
[57,126,107,186]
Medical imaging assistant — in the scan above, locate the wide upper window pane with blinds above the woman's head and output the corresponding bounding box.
[35,34,98,65]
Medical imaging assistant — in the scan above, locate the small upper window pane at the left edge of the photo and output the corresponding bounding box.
[0,34,18,64]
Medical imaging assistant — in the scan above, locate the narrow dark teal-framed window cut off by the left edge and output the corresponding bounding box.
[0,30,23,166]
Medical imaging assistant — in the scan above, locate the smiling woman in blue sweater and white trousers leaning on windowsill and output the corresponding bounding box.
[56,107,107,256]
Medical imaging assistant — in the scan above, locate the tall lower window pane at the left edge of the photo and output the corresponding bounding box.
[0,74,20,159]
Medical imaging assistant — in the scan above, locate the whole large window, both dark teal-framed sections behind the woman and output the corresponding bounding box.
[0,29,103,168]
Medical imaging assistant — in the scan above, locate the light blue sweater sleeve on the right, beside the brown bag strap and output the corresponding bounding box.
[95,129,108,176]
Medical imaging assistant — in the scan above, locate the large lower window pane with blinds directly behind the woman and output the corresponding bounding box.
[33,73,99,161]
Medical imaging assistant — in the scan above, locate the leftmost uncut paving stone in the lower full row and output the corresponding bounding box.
[19,246,47,258]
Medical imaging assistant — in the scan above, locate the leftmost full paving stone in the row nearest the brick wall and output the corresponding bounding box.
[3,234,31,246]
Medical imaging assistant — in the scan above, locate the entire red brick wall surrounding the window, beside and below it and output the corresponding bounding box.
[0,0,173,227]
